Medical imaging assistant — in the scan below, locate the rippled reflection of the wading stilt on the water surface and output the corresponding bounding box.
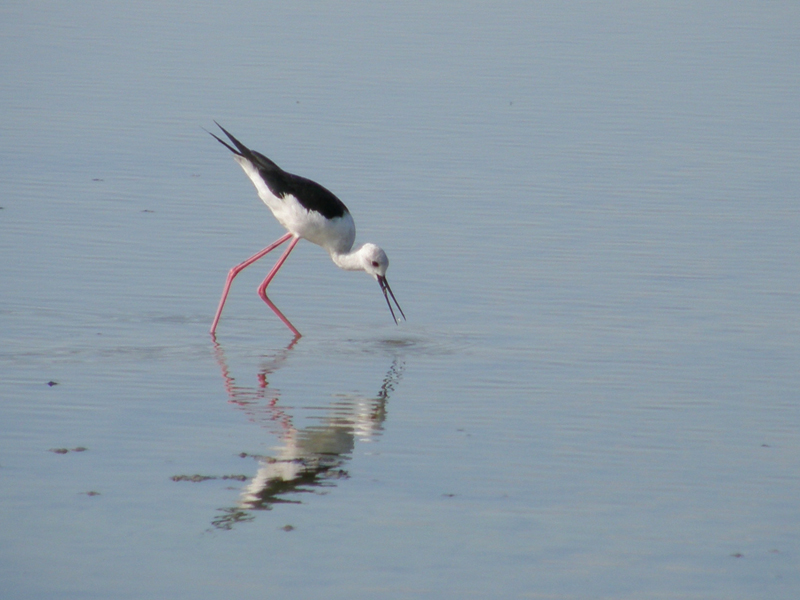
[212,338,403,529]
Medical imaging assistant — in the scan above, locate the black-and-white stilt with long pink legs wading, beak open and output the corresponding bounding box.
[206,121,406,338]
